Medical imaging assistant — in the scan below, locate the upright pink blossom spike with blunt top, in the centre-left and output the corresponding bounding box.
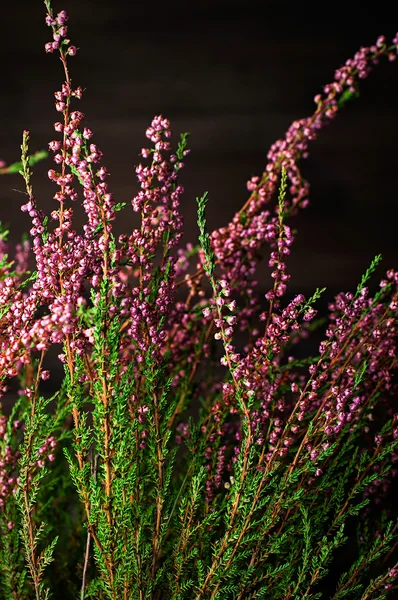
[119,116,187,362]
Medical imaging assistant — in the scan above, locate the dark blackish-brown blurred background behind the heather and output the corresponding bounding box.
[0,0,398,296]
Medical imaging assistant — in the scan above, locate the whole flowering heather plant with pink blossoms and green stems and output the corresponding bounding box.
[0,0,398,600]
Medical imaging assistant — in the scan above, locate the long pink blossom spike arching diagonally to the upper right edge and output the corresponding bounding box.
[188,34,398,326]
